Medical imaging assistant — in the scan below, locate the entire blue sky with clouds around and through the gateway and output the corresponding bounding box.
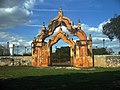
[0,0,120,53]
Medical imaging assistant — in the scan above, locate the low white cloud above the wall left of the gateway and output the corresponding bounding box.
[0,32,32,55]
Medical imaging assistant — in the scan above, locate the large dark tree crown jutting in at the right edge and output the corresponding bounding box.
[102,15,120,41]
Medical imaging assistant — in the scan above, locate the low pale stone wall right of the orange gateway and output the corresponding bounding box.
[94,55,120,67]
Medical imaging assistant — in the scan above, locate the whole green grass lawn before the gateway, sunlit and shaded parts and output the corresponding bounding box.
[0,66,120,90]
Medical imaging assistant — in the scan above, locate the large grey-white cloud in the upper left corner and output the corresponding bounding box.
[0,0,36,30]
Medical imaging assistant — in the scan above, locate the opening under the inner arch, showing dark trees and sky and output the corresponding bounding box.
[50,39,72,66]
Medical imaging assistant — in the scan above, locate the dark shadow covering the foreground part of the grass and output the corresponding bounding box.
[0,71,120,90]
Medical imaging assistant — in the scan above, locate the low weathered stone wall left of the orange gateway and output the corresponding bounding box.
[0,56,32,66]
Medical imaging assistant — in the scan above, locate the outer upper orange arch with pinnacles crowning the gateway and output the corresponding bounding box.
[34,9,87,42]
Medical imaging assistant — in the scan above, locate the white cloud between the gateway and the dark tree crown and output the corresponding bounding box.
[81,20,120,53]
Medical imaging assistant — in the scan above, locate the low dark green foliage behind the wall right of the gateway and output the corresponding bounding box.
[93,48,113,55]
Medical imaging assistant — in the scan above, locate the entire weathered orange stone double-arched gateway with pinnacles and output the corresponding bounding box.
[32,9,92,67]
